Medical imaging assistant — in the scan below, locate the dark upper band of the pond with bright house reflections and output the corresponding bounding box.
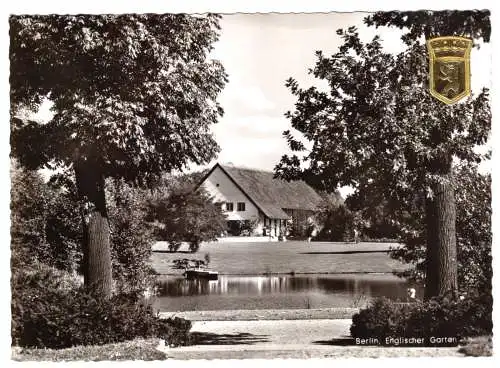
[159,275,414,299]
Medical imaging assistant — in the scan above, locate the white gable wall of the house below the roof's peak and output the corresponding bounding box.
[201,167,263,226]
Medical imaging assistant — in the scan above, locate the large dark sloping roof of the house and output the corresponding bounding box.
[208,164,322,219]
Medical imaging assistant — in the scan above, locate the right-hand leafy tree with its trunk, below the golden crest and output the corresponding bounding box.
[276,12,491,297]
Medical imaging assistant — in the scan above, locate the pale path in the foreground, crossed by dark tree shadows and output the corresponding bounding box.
[161,319,463,360]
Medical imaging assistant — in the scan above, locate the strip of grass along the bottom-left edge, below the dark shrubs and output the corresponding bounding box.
[12,339,166,362]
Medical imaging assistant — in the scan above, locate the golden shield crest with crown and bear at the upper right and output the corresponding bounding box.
[427,36,472,104]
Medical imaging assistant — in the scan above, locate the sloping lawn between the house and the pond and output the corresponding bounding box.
[152,241,408,275]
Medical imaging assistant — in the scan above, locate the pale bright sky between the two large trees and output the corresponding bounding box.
[196,12,491,175]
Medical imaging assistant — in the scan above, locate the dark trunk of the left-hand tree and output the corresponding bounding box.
[74,152,112,298]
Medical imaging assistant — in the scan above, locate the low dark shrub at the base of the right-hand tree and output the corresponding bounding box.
[351,294,493,341]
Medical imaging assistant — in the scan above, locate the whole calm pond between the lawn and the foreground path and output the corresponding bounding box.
[154,274,421,311]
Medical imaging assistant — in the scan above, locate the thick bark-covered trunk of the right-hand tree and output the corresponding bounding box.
[425,164,458,299]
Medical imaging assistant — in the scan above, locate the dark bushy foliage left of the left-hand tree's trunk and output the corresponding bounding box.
[11,161,82,271]
